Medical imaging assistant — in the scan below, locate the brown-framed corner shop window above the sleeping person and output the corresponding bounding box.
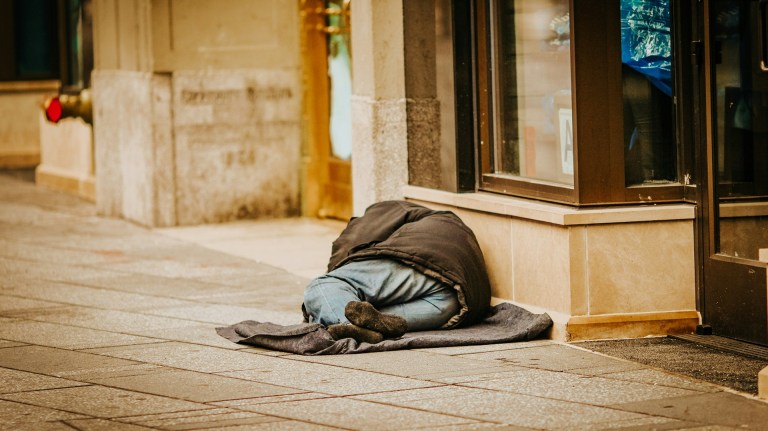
[468,0,690,205]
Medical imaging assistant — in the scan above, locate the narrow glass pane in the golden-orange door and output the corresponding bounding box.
[328,0,352,160]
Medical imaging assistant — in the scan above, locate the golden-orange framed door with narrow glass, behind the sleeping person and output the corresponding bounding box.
[301,0,352,220]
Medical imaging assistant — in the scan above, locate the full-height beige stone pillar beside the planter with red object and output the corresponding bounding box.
[92,0,170,226]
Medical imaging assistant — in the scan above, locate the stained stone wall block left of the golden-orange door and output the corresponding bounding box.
[172,69,301,224]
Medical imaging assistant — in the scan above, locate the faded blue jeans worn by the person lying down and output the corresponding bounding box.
[304,259,459,331]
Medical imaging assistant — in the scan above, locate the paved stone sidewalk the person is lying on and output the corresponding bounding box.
[0,175,768,431]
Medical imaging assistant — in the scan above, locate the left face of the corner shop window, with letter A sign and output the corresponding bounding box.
[477,0,575,202]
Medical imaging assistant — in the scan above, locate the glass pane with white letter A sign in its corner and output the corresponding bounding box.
[492,0,574,185]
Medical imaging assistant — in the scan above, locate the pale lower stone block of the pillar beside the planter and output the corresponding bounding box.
[91,70,171,226]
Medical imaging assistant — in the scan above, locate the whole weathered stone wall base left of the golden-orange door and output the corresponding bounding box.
[93,69,301,226]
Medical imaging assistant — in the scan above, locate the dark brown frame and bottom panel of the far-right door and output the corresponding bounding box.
[692,0,768,345]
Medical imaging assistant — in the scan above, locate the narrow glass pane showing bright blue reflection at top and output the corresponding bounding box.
[621,0,677,186]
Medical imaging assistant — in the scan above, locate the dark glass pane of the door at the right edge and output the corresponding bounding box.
[711,0,768,260]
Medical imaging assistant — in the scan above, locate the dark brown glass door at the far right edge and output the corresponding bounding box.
[701,0,768,345]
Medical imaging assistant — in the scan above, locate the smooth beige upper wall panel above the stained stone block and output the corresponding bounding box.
[152,0,299,71]
